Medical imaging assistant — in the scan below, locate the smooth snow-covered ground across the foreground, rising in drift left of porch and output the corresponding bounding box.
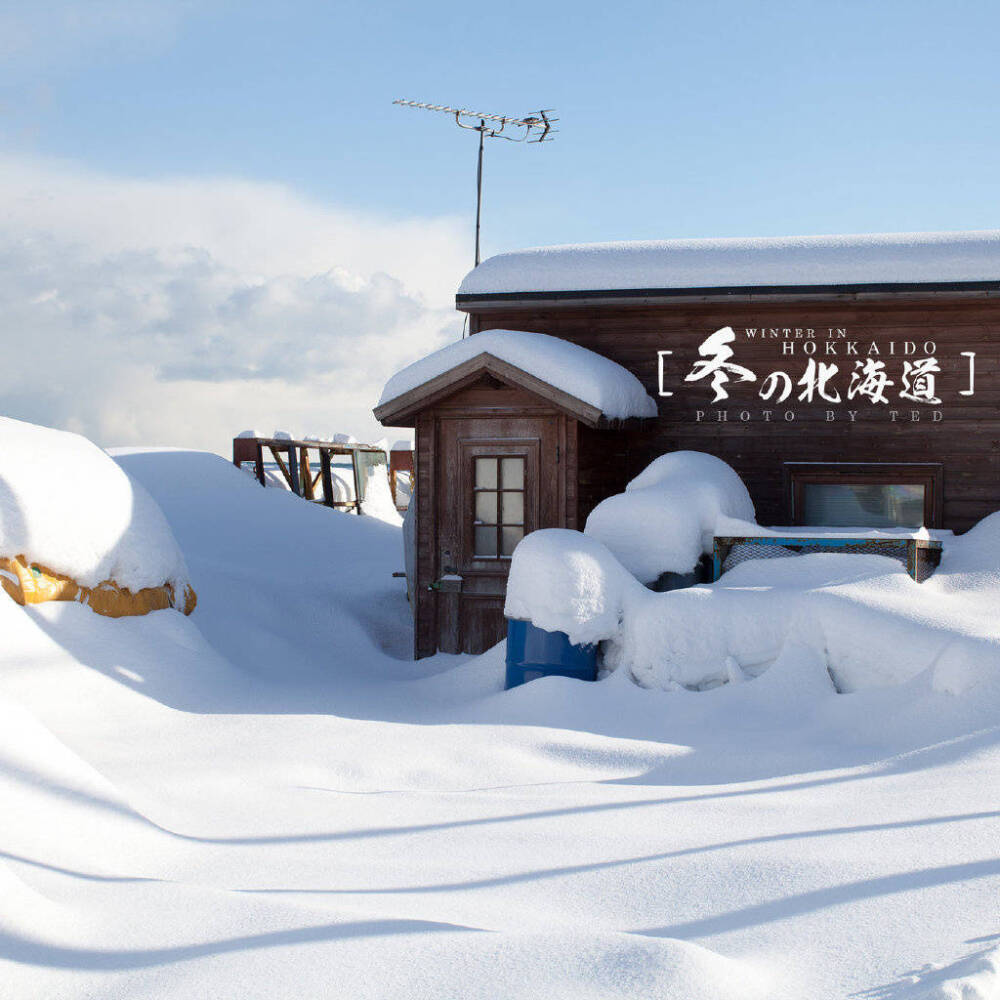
[0,451,1000,1000]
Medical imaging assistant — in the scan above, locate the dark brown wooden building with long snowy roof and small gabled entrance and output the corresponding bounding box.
[376,232,1000,656]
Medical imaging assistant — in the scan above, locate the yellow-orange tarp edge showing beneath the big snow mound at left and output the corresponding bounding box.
[0,556,198,618]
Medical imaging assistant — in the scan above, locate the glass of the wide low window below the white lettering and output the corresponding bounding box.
[802,483,924,528]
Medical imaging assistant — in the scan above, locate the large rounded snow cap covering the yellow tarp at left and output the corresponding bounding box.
[0,417,188,602]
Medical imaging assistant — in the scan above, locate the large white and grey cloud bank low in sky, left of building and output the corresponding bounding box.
[0,157,468,453]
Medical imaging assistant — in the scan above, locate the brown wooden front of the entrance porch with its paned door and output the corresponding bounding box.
[434,415,565,653]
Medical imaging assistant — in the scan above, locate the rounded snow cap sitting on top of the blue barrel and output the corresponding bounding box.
[504,528,639,643]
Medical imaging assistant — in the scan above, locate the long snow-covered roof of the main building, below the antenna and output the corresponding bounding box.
[458,230,1000,302]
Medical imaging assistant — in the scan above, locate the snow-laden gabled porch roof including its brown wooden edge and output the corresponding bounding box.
[375,330,657,426]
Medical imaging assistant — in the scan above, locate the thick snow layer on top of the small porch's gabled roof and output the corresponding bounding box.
[379,330,657,420]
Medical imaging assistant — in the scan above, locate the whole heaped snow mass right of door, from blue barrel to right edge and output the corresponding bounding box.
[506,452,1000,694]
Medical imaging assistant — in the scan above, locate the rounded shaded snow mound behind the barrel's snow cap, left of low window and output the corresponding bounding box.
[584,451,754,583]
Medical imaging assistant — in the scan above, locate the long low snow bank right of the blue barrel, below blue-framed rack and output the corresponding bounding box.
[611,528,1000,694]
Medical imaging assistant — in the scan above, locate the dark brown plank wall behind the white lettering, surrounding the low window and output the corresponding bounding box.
[467,296,1000,531]
